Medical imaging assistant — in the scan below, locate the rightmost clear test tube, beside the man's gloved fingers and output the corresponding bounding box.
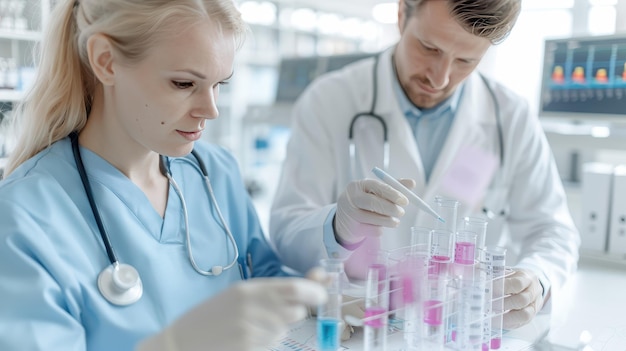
[485,246,506,350]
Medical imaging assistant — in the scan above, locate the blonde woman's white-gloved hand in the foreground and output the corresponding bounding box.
[137,278,328,351]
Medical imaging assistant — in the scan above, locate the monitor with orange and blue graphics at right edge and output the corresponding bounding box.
[539,35,626,121]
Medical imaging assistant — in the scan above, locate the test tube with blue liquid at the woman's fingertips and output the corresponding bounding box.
[317,259,344,351]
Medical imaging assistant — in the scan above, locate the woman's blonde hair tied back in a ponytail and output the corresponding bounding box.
[5,0,247,175]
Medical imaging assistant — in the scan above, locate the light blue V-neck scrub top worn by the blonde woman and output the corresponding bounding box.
[0,138,286,351]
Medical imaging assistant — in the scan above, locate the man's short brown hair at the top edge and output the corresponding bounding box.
[403,0,522,44]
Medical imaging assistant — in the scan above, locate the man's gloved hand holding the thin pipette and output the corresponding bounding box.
[334,179,415,245]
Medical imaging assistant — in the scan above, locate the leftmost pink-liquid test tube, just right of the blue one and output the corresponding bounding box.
[363,264,389,351]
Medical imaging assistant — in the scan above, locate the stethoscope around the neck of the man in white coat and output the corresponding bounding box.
[348,54,506,219]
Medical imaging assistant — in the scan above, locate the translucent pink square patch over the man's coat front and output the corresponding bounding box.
[441,146,499,208]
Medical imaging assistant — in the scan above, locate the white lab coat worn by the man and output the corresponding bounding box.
[270,49,580,294]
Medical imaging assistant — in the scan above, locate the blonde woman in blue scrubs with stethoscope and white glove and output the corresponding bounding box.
[0,0,326,351]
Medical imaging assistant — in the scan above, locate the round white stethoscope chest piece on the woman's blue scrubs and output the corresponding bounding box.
[98,263,143,306]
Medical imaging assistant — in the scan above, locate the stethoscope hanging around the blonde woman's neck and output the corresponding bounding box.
[70,132,239,306]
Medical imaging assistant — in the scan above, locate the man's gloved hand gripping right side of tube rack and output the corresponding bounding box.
[502,269,543,329]
